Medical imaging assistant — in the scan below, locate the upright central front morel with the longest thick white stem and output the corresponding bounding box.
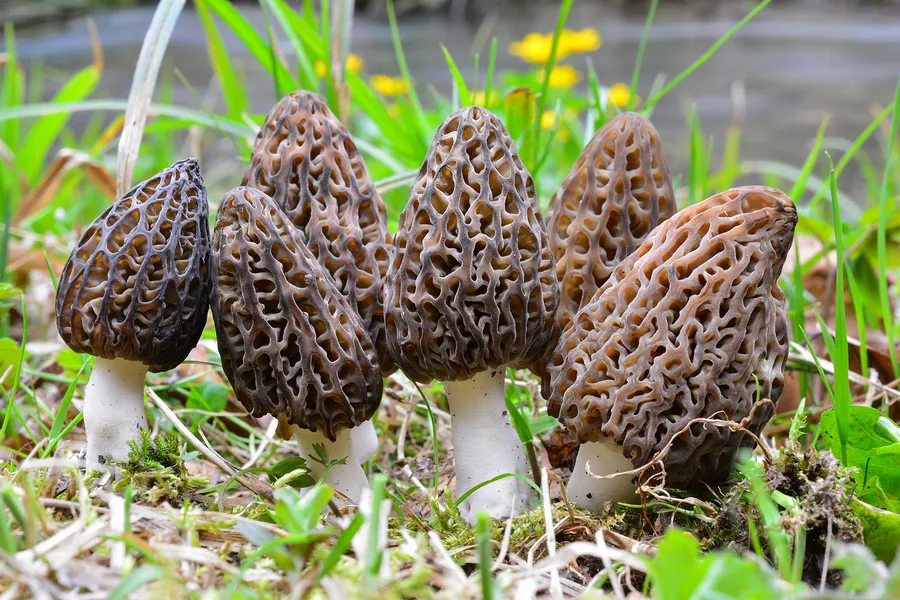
[385,107,559,522]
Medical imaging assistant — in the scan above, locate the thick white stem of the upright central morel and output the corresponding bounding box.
[444,369,531,523]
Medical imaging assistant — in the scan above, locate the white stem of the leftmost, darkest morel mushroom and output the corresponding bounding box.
[84,358,148,471]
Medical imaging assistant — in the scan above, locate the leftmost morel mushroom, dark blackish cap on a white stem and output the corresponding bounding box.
[56,158,210,469]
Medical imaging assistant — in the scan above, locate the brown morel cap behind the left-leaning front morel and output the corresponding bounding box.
[243,91,394,375]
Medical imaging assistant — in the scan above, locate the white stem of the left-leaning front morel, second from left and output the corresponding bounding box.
[292,425,371,504]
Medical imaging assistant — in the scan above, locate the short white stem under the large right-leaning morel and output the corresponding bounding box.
[566,439,637,512]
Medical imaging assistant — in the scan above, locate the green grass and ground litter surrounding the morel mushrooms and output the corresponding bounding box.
[0,0,900,600]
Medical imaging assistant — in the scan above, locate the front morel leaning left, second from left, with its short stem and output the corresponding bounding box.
[212,187,383,503]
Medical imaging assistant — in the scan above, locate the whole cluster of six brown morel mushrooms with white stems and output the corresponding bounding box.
[56,91,797,522]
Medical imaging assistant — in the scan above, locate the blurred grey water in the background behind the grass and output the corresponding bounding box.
[8,0,900,205]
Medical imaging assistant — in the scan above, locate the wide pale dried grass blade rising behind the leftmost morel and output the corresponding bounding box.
[116,0,184,196]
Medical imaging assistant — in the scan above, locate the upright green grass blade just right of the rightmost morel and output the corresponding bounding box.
[828,156,853,465]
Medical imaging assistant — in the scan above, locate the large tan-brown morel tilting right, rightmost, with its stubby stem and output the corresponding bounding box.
[549,187,797,509]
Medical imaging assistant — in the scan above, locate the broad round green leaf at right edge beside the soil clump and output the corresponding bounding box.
[819,406,900,498]
